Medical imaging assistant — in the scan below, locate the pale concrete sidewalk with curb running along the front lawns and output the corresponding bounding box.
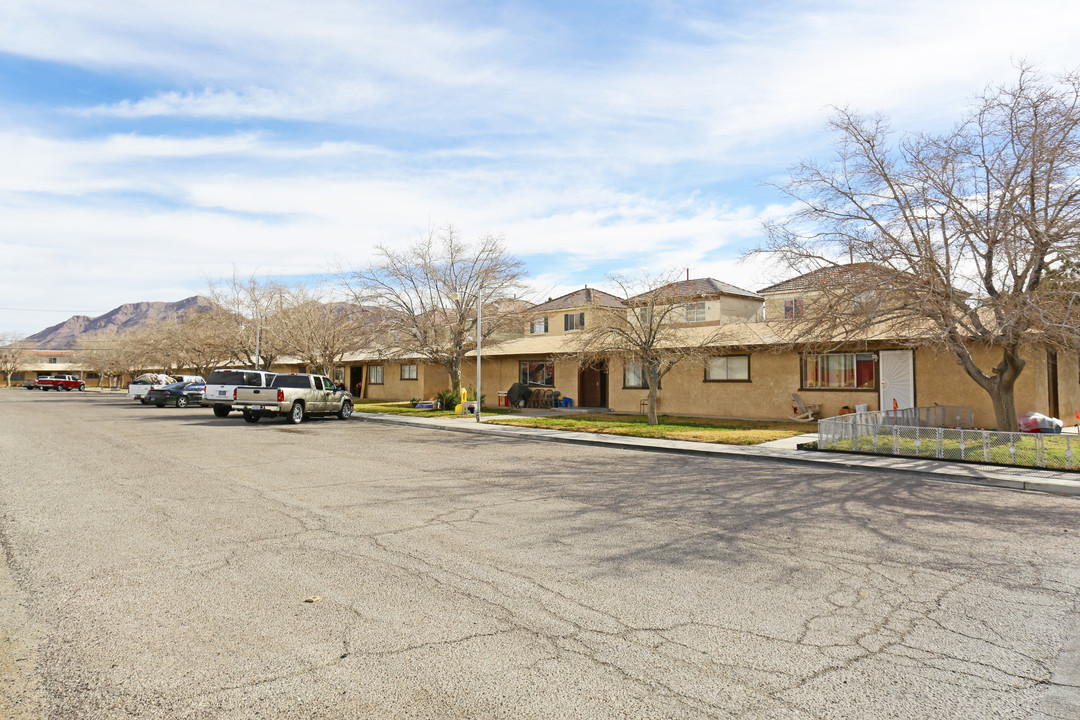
[353,412,1080,495]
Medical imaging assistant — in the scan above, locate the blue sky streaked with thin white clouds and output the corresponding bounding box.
[0,0,1080,335]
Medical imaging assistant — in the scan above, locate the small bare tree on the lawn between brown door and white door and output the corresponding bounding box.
[575,271,720,425]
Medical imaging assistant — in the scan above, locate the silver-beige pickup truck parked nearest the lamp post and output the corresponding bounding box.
[231,372,352,424]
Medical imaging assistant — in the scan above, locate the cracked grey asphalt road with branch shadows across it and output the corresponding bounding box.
[0,390,1080,720]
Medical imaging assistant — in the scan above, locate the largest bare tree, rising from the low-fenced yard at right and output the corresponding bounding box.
[760,66,1080,430]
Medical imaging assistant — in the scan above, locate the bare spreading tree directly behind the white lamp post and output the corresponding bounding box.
[339,226,526,390]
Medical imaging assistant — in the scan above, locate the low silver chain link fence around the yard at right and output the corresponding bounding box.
[818,405,1080,471]
